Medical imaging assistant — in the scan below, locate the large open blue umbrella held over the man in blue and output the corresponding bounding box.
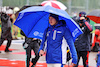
[14,6,82,41]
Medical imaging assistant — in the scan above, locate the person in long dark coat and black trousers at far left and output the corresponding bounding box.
[0,13,12,52]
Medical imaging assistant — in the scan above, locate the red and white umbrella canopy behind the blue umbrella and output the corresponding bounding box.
[41,1,67,10]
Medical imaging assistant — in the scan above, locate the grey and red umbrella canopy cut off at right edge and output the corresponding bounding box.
[87,9,100,23]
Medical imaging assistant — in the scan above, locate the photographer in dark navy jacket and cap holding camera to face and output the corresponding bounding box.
[75,11,93,67]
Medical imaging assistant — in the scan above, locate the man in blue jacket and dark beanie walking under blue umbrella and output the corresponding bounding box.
[39,14,77,67]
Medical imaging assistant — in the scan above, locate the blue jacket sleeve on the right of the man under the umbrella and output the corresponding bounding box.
[64,28,77,64]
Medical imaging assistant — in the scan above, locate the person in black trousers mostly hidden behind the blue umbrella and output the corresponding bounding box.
[21,30,41,67]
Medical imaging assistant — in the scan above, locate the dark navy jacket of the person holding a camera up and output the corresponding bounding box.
[74,19,93,51]
